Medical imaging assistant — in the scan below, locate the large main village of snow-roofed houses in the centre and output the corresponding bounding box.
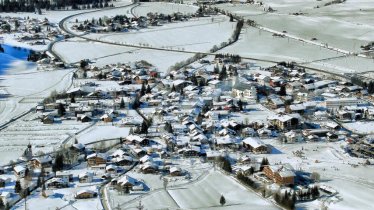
[1,48,374,208]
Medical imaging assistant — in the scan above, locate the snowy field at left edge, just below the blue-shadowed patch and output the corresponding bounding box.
[0,69,72,123]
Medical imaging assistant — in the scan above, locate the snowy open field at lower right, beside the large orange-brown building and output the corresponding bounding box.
[264,140,374,210]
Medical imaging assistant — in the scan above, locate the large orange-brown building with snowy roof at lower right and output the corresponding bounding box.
[263,164,296,185]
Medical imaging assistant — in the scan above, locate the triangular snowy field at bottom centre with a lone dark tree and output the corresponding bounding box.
[121,171,278,209]
